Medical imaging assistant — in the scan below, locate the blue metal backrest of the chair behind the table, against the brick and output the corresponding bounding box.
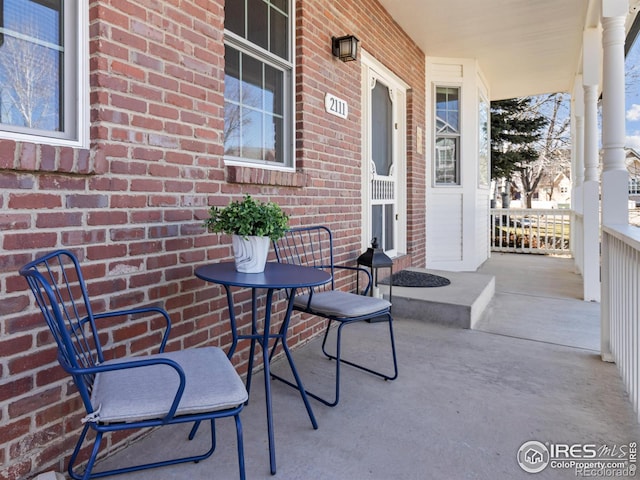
[273,225,335,291]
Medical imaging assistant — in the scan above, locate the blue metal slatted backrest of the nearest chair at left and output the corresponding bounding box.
[20,250,104,411]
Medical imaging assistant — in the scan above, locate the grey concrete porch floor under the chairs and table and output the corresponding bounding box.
[92,254,640,480]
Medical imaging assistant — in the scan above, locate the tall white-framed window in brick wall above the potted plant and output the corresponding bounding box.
[224,0,293,167]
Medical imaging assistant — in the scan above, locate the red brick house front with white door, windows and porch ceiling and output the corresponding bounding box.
[0,0,633,480]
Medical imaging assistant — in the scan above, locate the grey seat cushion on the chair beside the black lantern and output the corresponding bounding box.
[294,290,391,318]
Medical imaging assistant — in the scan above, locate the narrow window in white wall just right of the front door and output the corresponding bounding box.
[434,87,460,185]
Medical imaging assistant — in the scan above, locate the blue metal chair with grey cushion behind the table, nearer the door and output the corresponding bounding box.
[271,225,398,407]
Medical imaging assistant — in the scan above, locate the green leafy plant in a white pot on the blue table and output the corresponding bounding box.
[204,195,289,273]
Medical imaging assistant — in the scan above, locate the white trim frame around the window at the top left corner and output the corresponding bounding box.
[0,1,89,148]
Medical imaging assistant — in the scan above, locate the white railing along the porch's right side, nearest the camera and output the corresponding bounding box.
[601,225,640,421]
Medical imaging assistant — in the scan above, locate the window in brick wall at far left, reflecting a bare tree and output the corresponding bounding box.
[0,0,86,144]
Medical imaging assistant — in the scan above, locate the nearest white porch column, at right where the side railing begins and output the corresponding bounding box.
[600,0,629,360]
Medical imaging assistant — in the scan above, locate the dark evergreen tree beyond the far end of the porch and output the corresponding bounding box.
[491,97,547,181]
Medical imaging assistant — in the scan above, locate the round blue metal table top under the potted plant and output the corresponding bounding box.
[195,262,331,288]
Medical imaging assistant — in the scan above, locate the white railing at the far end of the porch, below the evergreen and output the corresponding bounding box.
[490,208,572,254]
